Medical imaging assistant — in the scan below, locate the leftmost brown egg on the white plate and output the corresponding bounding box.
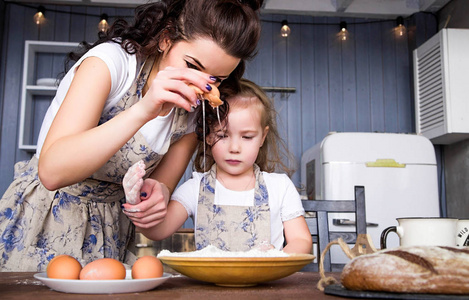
[46,254,82,279]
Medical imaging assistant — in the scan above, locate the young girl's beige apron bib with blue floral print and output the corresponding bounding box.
[195,164,270,251]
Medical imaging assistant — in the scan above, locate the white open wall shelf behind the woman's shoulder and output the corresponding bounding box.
[18,41,78,152]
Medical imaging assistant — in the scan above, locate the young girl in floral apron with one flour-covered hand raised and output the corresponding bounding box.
[124,80,312,253]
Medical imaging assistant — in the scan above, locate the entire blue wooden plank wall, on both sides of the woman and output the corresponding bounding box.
[0,3,438,194]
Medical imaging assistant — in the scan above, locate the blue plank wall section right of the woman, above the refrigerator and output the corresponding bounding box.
[246,14,437,183]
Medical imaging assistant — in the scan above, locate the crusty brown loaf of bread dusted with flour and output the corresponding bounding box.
[341,246,469,294]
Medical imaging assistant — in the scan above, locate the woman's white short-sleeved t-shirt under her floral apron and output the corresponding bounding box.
[36,42,195,157]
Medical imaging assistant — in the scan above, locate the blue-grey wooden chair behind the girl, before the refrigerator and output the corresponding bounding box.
[302,186,367,272]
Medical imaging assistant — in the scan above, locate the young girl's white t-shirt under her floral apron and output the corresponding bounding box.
[171,172,305,250]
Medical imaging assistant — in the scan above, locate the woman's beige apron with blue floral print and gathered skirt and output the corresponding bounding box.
[0,57,187,271]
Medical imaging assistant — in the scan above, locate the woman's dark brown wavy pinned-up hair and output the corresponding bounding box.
[67,0,264,89]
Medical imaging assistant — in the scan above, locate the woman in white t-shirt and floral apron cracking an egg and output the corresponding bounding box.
[0,0,262,271]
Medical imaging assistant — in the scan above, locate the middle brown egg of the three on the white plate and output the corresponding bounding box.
[80,258,125,280]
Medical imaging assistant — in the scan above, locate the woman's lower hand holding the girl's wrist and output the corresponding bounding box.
[122,178,169,228]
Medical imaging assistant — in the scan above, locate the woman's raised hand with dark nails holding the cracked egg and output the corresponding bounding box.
[135,67,214,120]
